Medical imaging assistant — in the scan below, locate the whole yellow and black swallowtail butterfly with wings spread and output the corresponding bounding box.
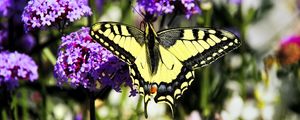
[90,22,241,117]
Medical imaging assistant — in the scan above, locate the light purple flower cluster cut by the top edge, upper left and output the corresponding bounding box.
[22,0,92,30]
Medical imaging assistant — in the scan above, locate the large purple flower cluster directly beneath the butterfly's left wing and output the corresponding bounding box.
[54,28,137,95]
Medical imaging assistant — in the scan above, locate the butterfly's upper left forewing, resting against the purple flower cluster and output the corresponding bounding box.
[90,22,145,64]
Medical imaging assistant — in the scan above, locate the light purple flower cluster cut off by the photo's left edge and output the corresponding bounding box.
[0,51,38,89]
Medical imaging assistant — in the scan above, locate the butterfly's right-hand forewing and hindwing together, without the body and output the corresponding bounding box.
[149,28,240,111]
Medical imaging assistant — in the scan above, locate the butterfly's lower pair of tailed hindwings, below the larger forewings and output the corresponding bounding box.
[135,46,194,116]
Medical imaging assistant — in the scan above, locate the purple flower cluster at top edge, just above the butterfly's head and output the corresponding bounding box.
[137,0,200,19]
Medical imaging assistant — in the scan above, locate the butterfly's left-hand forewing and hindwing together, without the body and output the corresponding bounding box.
[90,22,150,101]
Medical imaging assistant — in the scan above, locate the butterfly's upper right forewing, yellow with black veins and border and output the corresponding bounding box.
[157,28,241,69]
